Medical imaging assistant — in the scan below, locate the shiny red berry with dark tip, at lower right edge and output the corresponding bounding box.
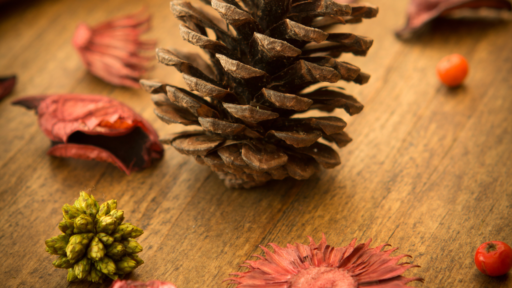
[475,241,512,276]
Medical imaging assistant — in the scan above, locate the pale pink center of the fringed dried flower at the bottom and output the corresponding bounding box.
[290,267,357,288]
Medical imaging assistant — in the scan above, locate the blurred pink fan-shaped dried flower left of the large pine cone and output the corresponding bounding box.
[73,9,156,88]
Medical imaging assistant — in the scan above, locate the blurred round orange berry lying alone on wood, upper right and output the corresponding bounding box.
[436,54,469,87]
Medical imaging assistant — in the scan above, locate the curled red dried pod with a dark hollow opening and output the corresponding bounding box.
[13,94,163,174]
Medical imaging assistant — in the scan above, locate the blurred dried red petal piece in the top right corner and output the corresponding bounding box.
[396,0,512,38]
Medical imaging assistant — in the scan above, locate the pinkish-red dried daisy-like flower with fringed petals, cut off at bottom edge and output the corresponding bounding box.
[226,236,423,288]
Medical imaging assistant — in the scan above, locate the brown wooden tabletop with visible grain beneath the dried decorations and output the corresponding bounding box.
[0,0,512,288]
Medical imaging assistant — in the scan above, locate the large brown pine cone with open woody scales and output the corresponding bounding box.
[141,0,378,188]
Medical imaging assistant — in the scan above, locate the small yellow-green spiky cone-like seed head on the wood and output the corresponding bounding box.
[45,192,144,283]
